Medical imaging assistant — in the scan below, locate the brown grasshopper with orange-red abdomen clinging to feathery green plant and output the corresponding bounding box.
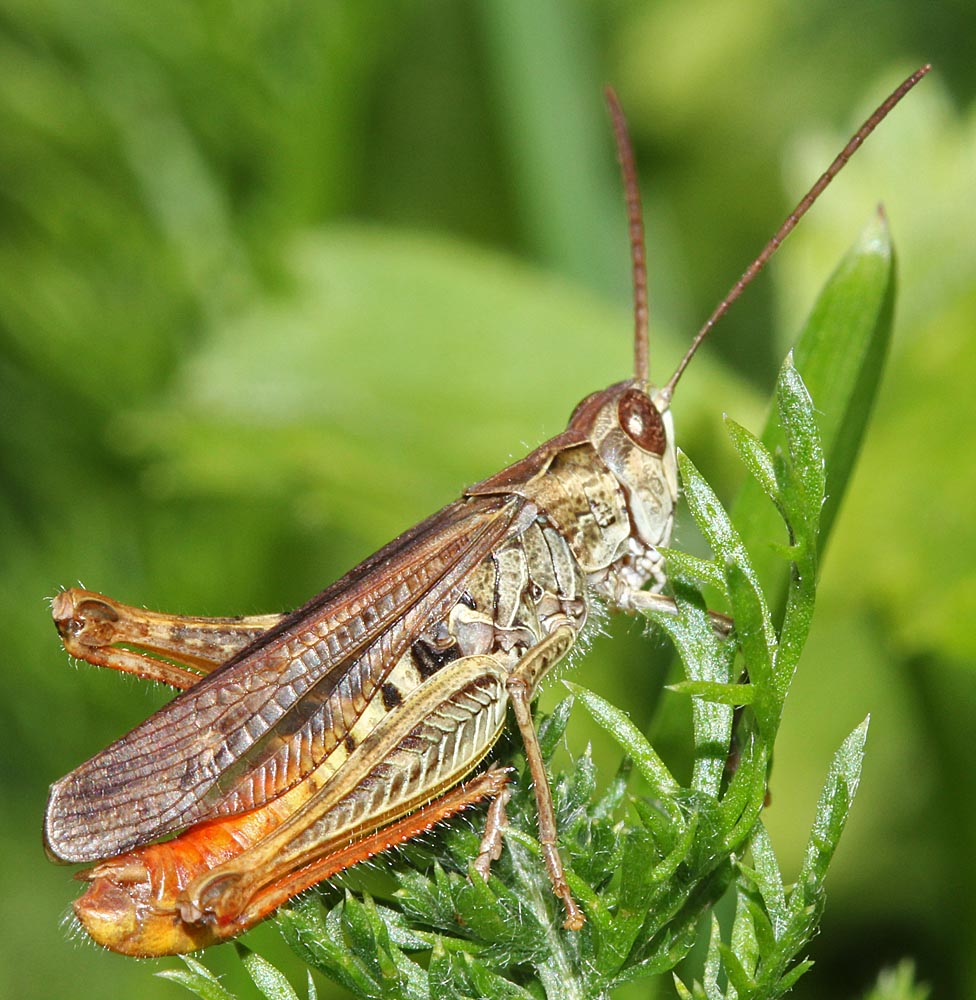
[44,66,928,955]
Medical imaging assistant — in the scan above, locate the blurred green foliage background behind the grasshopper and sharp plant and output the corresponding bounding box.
[0,0,976,998]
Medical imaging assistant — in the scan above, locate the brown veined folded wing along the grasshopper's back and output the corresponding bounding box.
[44,495,525,861]
